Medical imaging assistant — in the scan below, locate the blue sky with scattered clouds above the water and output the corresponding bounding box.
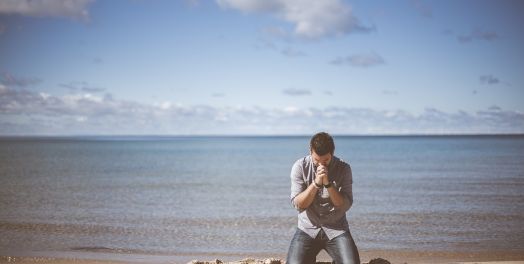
[0,0,524,135]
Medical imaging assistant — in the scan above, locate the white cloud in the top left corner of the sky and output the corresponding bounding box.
[0,0,93,19]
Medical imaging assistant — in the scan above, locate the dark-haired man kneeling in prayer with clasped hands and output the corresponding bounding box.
[286,132,360,264]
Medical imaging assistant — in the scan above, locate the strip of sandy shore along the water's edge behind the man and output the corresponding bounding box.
[0,250,524,264]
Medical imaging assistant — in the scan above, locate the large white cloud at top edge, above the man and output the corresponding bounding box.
[217,0,373,39]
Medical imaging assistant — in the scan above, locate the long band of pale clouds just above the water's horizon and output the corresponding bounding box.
[0,85,524,135]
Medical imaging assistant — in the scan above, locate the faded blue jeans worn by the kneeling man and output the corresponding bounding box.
[286,228,360,264]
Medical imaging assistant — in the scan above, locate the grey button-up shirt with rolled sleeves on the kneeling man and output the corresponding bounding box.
[291,155,353,240]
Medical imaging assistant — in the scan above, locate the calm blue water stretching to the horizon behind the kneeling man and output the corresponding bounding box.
[0,136,524,255]
